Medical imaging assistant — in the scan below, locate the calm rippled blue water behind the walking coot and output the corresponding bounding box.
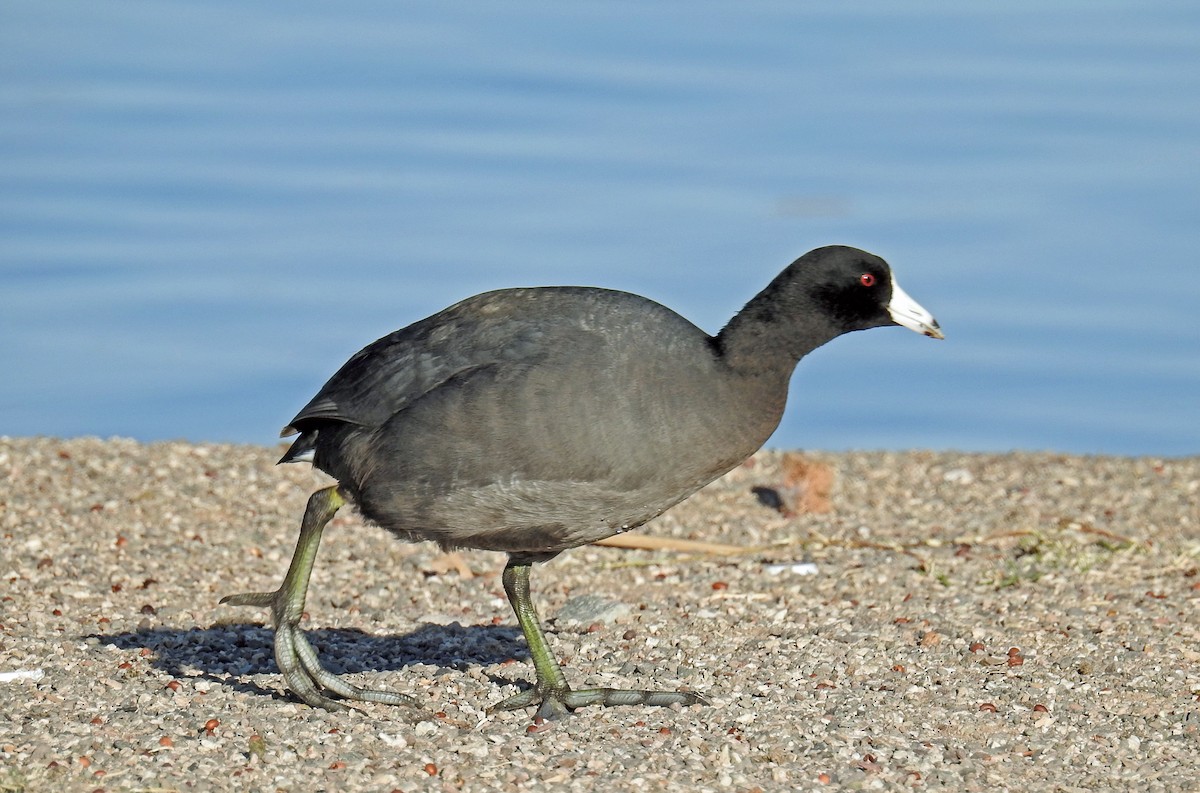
[0,0,1200,455]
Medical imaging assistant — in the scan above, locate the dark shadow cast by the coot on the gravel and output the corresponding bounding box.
[82,623,529,698]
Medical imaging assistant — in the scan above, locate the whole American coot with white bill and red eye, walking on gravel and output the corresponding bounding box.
[221,246,942,717]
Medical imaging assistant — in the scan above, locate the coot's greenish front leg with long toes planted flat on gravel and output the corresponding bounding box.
[488,558,708,720]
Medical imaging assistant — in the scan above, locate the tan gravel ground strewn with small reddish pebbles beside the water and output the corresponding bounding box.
[0,438,1200,793]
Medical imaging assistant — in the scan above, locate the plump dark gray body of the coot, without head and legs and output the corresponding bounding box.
[280,287,791,555]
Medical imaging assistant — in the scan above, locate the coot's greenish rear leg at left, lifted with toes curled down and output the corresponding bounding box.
[221,487,418,710]
